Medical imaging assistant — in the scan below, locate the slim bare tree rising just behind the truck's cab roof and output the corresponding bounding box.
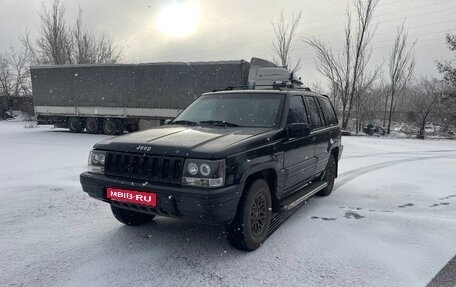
[272,11,302,72]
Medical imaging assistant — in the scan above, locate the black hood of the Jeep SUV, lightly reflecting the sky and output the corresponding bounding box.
[94,126,278,158]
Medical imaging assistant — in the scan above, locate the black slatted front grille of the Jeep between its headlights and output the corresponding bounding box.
[105,152,184,184]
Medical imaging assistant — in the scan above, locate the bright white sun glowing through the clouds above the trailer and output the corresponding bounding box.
[155,1,200,38]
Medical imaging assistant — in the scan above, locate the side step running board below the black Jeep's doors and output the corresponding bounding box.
[267,182,328,237]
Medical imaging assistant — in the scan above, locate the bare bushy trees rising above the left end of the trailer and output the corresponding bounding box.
[21,0,122,65]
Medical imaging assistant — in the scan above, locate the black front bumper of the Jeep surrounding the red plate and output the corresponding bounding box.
[80,172,243,223]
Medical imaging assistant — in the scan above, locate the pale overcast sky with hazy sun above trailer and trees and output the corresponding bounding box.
[0,0,456,90]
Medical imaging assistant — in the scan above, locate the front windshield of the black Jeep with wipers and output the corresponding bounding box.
[173,93,285,127]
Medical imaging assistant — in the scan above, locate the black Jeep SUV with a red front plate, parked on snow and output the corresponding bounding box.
[80,89,343,250]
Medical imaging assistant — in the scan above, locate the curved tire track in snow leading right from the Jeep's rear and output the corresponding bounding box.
[334,155,455,190]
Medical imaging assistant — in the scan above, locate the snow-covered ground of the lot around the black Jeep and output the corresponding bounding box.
[0,122,456,286]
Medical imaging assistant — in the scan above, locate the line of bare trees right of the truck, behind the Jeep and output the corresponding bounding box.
[272,0,456,138]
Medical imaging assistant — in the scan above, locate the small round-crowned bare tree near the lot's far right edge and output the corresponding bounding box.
[409,78,447,139]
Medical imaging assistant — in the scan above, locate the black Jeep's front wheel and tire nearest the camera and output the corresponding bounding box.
[225,179,271,251]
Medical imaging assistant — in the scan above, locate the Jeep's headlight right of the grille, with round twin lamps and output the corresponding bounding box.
[182,159,225,187]
